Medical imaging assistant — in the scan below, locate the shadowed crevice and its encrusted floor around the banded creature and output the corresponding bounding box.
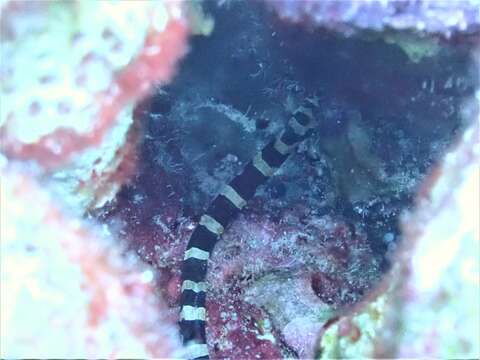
[102,3,477,358]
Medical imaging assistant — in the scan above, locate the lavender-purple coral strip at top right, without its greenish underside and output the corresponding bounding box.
[267,0,480,36]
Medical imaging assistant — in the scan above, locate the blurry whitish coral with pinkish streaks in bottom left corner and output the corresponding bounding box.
[0,167,180,358]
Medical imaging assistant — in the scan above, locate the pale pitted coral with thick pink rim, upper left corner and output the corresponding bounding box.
[1,1,188,165]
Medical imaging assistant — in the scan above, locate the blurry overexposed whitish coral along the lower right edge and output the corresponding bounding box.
[377,100,480,358]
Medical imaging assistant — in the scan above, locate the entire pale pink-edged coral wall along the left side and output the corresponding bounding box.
[0,1,190,358]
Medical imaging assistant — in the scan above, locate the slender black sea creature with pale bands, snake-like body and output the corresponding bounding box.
[180,101,317,359]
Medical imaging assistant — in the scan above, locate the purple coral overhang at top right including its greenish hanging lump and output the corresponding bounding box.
[266,0,480,62]
